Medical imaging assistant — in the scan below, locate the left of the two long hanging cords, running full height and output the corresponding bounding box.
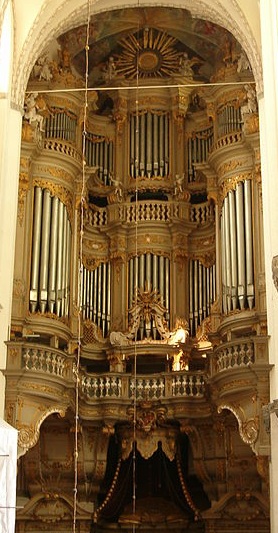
[73,0,90,533]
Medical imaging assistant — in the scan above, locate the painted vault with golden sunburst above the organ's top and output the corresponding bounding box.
[53,7,245,86]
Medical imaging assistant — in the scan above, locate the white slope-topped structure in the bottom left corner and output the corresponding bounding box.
[0,419,17,533]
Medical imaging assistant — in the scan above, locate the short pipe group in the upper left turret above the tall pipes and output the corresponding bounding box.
[45,108,77,143]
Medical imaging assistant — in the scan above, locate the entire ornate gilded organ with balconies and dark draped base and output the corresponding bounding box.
[5,7,269,533]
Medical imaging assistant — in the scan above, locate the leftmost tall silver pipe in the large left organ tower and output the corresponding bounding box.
[30,187,42,313]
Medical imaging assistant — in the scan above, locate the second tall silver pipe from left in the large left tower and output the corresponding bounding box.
[40,189,51,313]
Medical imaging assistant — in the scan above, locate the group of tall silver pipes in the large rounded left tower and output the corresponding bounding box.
[30,187,71,317]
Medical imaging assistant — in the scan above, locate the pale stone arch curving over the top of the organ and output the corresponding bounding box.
[12,0,262,108]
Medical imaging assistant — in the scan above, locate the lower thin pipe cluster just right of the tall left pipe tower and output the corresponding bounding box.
[81,263,111,337]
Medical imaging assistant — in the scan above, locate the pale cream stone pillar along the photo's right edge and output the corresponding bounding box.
[259,0,278,533]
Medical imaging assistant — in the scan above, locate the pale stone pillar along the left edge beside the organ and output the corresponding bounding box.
[0,96,22,417]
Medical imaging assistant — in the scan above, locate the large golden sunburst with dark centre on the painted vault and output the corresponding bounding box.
[116,28,180,79]
